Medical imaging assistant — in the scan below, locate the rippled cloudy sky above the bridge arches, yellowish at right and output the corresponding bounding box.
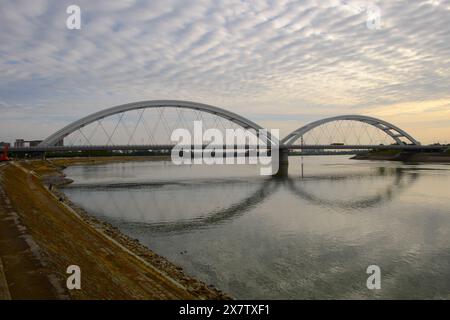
[0,0,450,143]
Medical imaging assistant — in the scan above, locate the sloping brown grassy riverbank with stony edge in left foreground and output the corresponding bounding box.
[0,158,229,299]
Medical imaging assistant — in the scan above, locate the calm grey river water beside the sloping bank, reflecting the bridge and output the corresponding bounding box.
[64,156,450,299]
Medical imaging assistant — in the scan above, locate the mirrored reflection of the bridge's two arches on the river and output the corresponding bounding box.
[65,162,418,233]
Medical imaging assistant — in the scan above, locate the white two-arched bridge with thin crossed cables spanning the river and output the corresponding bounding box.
[7,100,446,158]
